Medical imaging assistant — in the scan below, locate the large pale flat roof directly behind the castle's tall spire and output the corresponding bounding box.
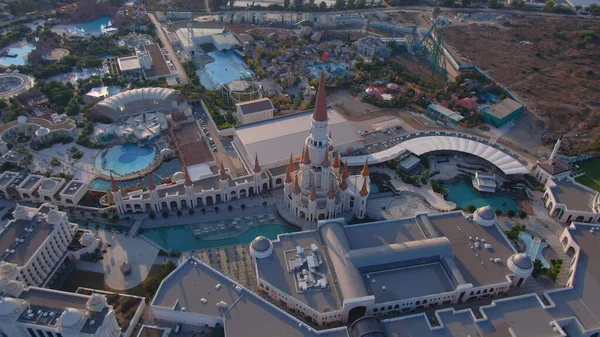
[235,108,364,166]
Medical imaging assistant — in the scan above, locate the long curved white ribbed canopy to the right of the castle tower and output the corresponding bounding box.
[344,131,529,175]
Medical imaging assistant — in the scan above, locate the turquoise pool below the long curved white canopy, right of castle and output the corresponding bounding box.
[444,180,519,212]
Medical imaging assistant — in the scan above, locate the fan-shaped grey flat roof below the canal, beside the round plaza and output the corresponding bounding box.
[152,261,240,317]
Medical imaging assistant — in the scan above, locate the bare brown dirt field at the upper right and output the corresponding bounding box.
[444,16,600,153]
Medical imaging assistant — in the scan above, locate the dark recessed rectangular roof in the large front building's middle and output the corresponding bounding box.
[363,263,454,303]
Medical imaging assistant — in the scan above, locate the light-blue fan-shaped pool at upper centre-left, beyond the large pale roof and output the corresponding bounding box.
[197,51,254,89]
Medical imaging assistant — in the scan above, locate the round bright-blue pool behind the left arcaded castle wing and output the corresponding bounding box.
[95,143,157,176]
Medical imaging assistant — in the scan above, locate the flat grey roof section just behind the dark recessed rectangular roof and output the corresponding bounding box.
[344,218,425,249]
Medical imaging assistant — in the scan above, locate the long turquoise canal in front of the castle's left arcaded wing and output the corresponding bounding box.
[140,224,298,252]
